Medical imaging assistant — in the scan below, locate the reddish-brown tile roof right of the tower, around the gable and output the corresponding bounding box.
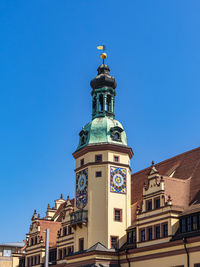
[131,147,200,207]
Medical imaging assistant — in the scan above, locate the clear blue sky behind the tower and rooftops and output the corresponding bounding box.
[0,0,200,242]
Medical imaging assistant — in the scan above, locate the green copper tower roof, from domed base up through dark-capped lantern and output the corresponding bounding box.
[76,61,127,151]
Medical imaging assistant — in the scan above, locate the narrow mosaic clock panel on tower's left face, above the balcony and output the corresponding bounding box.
[76,169,88,209]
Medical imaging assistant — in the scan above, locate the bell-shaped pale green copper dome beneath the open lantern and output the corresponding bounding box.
[77,117,127,153]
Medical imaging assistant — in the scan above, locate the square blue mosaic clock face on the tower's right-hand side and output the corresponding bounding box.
[110,167,126,194]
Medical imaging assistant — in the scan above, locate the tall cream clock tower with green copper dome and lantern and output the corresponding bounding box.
[71,56,133,252]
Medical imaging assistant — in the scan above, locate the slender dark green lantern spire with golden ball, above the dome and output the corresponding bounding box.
[90,53,117,119]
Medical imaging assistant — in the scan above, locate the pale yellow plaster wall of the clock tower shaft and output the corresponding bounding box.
[75,150,131,251]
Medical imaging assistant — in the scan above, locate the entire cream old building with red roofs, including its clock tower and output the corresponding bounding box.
[20,57,200,267]
